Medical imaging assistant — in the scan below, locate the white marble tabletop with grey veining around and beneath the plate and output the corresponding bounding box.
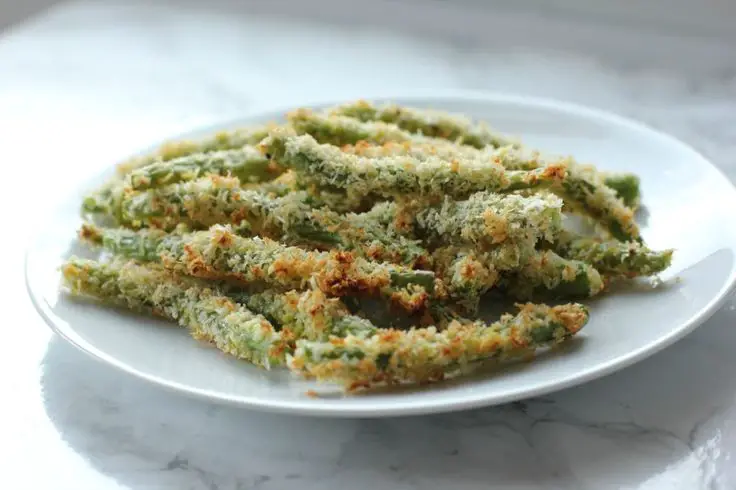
[0,0,736,490]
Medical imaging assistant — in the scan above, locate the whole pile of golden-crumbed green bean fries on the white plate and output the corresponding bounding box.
[62,101,672,391]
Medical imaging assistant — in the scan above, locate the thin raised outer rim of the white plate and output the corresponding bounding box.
[23,90,736,418]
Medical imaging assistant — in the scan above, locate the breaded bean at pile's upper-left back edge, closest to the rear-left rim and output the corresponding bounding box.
[118,123,277,175]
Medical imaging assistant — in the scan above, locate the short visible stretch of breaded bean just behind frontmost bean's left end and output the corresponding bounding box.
[236,290,378,340]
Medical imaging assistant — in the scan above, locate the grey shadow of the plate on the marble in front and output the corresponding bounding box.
[40,310,736,489]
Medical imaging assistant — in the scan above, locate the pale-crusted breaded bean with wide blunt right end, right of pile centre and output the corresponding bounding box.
[366,191,562,249]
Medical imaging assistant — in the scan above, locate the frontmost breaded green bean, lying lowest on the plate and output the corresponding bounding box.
[288,304,588,390]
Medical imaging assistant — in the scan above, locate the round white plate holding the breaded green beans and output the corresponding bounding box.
[26,93,736,416]
